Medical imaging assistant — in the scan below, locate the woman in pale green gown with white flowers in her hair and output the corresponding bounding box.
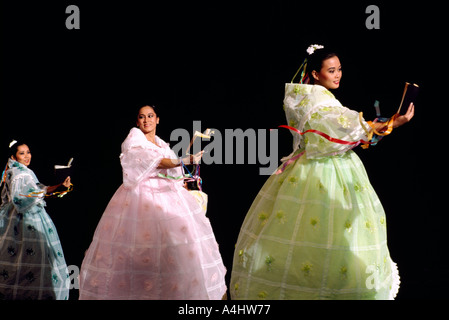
[230,46,414,300]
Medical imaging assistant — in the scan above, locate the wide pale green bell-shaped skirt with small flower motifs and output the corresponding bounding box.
[230,150,399,300]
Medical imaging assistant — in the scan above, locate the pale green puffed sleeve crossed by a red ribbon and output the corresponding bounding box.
[304,105,369,159]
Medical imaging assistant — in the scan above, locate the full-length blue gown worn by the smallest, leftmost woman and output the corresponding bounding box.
[0,159,70,300]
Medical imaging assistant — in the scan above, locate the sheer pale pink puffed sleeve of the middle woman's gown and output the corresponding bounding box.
[120,128,164,187]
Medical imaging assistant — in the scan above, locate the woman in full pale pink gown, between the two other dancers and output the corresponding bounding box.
[80,106,226,300]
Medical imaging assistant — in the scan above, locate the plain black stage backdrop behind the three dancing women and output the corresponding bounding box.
[0,0,449,299]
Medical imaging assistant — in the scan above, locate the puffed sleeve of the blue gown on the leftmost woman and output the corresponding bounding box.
[11,173,47,213]
